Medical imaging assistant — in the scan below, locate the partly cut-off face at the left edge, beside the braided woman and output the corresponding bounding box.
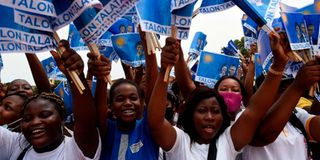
[0,95,24,125]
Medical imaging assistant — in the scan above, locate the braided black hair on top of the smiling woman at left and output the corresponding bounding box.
[23,92,66,120]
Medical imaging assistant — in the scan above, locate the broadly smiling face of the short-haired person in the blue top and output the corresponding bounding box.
[111,83,141,123]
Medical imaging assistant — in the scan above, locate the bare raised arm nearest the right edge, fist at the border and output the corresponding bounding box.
[252,61,320,146]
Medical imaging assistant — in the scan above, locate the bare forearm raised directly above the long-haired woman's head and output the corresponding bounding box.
[174,42,196,99]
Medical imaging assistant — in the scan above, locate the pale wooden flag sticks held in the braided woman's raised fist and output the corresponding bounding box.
[53,32,85,94]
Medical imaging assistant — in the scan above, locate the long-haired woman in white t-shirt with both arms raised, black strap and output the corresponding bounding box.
[148,32,288,160]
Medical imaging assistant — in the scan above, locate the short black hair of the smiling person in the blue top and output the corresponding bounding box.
[109,79,143,105]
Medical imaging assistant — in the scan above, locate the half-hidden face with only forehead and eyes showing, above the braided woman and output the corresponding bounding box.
[8,79,33,97]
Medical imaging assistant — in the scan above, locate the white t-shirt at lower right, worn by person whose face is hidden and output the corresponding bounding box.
[242,108,313,160]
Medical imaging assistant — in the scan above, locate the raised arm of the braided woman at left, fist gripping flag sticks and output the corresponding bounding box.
[51,41,99,158]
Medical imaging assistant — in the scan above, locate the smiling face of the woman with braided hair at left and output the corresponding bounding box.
[20,99,63,149]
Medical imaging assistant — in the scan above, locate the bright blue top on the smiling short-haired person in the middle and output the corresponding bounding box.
[100,116,159,160]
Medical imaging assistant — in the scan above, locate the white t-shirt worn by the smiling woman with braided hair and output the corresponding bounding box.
[0,127,101,160]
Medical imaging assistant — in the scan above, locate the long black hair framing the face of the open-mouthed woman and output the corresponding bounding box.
[182,86,230,157]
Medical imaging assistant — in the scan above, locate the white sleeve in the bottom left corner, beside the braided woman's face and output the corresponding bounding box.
[0,127,22,159]
